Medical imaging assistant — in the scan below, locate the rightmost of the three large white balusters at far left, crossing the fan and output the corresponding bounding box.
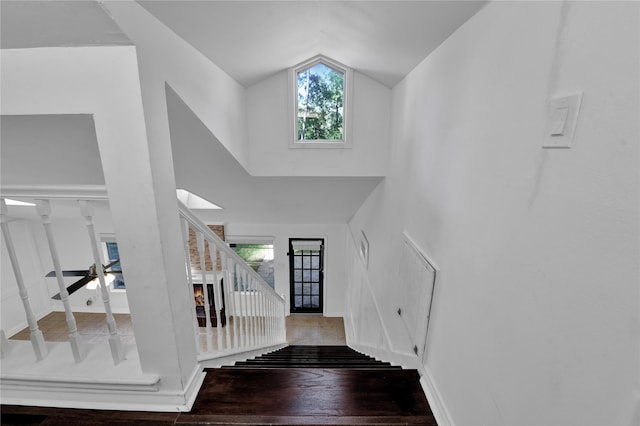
[78,201,124,365]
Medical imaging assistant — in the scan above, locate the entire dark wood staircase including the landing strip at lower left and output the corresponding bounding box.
[1,346,436,426]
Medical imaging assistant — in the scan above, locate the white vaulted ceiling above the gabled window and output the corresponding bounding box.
[138,0,486,87]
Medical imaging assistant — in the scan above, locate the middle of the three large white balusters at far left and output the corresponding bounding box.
[36,200,83,363]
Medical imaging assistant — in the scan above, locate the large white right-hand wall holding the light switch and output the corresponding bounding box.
[346,2,640,425]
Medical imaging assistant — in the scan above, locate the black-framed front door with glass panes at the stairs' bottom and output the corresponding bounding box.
[289,238,324,313]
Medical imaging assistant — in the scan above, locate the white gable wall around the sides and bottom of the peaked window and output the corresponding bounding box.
[247,70,391,176]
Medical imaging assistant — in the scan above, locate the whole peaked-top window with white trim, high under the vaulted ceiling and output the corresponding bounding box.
[289,56,352,148]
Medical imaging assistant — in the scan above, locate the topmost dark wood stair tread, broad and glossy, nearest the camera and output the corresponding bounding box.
[184,368,431,421]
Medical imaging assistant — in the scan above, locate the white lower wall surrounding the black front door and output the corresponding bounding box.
[225,223,347,317]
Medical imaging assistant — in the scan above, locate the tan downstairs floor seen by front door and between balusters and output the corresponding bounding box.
[11,312,346,345]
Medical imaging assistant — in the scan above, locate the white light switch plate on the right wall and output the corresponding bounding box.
[542,92,582,148]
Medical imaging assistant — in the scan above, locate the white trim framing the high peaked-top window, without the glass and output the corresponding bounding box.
[288,55,353,148]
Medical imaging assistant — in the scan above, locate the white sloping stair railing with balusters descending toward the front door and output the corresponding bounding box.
[178,202,286,358]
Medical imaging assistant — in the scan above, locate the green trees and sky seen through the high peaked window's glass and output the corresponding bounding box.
[297,62,345,141]
